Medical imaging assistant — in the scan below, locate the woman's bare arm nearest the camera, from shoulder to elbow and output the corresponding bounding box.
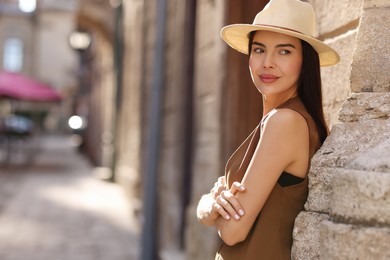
[215,109,309,245]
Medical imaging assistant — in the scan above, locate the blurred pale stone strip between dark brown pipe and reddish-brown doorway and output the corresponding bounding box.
[186,0,227,259]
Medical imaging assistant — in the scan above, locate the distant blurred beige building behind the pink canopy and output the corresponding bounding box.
[0,0,78,130]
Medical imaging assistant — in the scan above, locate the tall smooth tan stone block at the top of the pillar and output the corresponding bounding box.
[351,8,390,92]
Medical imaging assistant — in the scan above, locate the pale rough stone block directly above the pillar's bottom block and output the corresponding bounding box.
[330,170,390,226]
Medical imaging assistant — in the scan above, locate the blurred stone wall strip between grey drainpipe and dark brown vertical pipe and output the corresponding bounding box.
[158,0,191,260]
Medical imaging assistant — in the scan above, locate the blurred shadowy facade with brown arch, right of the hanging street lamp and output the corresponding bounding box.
[74,0,118,170]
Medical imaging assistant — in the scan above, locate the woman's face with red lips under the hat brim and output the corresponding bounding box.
[249,31,302,98]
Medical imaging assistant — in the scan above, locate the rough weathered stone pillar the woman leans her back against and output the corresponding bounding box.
[293,0,390,259]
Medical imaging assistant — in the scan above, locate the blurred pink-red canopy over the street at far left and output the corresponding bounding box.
[0,72,61,101]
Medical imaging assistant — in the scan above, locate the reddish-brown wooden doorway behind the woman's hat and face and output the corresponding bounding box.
[221,0,269,161]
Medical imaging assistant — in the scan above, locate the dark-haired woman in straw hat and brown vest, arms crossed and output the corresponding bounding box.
[197,0,339,260]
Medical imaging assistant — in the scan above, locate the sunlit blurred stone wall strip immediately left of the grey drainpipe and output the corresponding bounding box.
[115,0,147,223]
